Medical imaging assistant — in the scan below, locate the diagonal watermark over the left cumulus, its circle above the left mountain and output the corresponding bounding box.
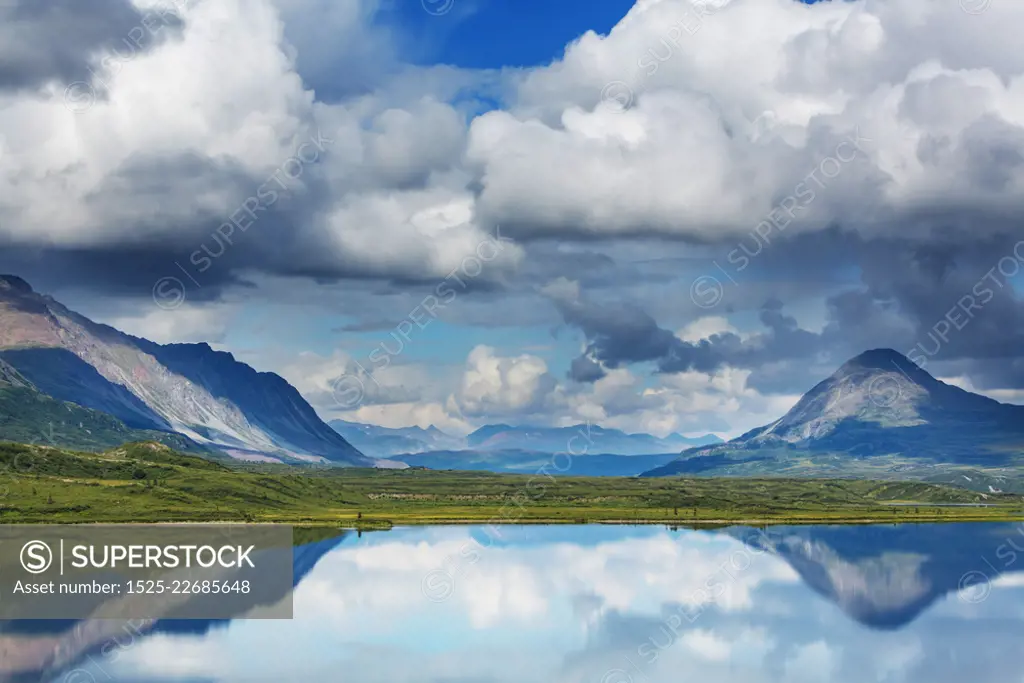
[153,130,334,310]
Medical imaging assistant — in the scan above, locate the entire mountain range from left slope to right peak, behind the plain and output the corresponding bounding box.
[8,275,1024,481]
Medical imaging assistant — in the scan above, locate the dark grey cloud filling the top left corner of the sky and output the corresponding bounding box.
[0,0,187,89]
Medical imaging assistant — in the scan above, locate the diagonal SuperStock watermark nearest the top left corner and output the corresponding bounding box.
[63,0,191,114]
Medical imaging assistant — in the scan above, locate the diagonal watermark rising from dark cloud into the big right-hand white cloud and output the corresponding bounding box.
[690,128,871,309]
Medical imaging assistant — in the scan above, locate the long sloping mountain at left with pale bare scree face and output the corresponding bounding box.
[0,275,376,466]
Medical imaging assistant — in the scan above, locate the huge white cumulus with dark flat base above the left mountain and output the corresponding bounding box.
[0,0,517,298]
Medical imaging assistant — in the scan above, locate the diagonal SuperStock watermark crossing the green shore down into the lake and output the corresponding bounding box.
[420,421,594,602]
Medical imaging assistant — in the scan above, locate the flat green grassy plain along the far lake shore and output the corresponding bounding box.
[0,443,1024,528]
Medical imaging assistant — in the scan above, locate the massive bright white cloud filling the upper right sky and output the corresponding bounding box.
[468,0,1024,241]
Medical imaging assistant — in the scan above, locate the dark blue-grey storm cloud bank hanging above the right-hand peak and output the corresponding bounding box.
[552,230,1024,393]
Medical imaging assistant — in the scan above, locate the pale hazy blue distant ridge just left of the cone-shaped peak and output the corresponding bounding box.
[466,425,722,456]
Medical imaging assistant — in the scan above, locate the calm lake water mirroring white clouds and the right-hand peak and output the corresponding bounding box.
[6,524,1024,683]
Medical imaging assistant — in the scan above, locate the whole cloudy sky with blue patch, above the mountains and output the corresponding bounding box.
[0,0,1024,436]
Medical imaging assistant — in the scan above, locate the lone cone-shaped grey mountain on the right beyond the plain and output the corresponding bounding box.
[645,349,1024,483]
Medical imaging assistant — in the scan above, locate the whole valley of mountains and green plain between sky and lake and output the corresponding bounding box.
[6,275,1024,511]
